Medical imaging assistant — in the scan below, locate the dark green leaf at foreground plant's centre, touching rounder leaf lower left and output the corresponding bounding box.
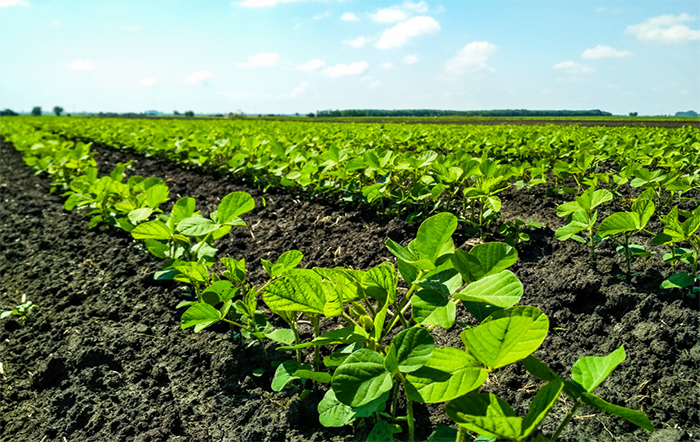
[387,327,435,373]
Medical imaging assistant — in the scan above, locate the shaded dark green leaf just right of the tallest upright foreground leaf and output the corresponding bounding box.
[452,242,518,282]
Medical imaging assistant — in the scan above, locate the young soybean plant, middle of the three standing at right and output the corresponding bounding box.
[598,189,655,279]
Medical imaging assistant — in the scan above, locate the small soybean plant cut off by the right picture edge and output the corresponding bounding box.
[654,206,700,298]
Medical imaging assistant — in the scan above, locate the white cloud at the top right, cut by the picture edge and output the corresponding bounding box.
[625,12,700,43]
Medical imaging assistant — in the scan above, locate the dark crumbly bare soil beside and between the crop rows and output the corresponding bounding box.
[0,137,700,442]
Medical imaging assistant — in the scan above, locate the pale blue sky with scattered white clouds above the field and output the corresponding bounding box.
[0,0,700,115]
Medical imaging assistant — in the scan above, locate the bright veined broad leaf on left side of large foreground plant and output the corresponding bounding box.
[263,276,326,314]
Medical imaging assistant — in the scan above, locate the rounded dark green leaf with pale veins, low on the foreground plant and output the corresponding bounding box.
[331,348,394,407]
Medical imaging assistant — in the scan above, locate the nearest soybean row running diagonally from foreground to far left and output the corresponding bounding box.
[0,117,653,442]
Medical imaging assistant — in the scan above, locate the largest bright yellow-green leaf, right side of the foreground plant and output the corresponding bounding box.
[460,307,549,369]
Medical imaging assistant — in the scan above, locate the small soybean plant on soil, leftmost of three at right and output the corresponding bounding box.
[554,187,613,263]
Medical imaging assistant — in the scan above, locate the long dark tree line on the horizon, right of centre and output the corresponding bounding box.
[316,109,612,118]
